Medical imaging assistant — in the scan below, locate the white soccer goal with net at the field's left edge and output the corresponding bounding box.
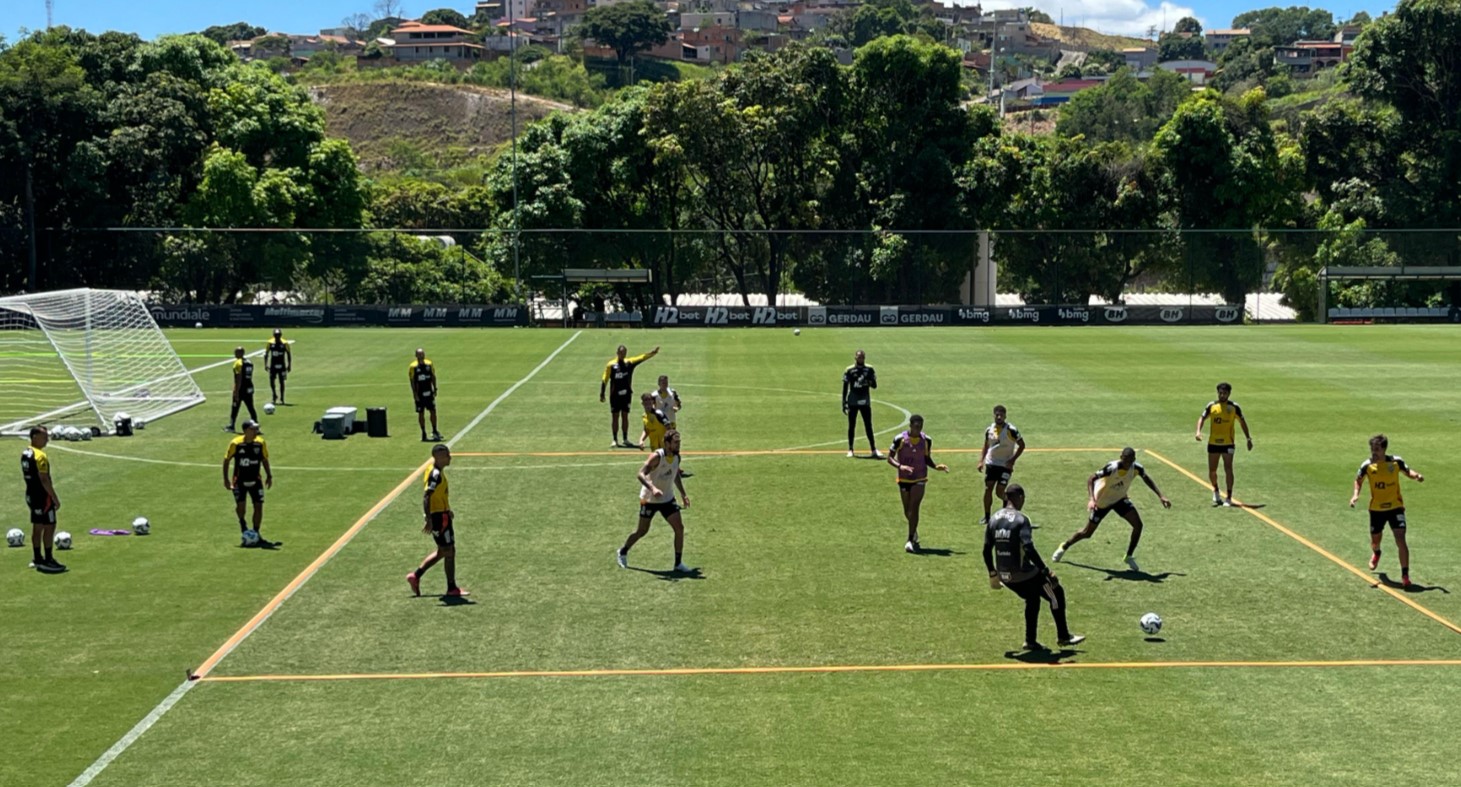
[0,289,203,434]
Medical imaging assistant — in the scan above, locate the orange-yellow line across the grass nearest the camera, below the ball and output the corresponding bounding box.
[200,659,1461,683]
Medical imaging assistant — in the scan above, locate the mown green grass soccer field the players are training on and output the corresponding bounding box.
[0,326,1461,787]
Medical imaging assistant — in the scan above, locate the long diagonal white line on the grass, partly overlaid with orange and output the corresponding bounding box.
[72,331,583,787]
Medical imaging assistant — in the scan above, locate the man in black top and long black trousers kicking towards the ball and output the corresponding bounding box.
[985,483,1086,650]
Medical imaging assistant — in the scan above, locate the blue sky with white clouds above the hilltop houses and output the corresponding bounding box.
[14,0,1394,39]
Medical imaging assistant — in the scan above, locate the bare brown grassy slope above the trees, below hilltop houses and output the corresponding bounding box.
[308,82,574,171]
